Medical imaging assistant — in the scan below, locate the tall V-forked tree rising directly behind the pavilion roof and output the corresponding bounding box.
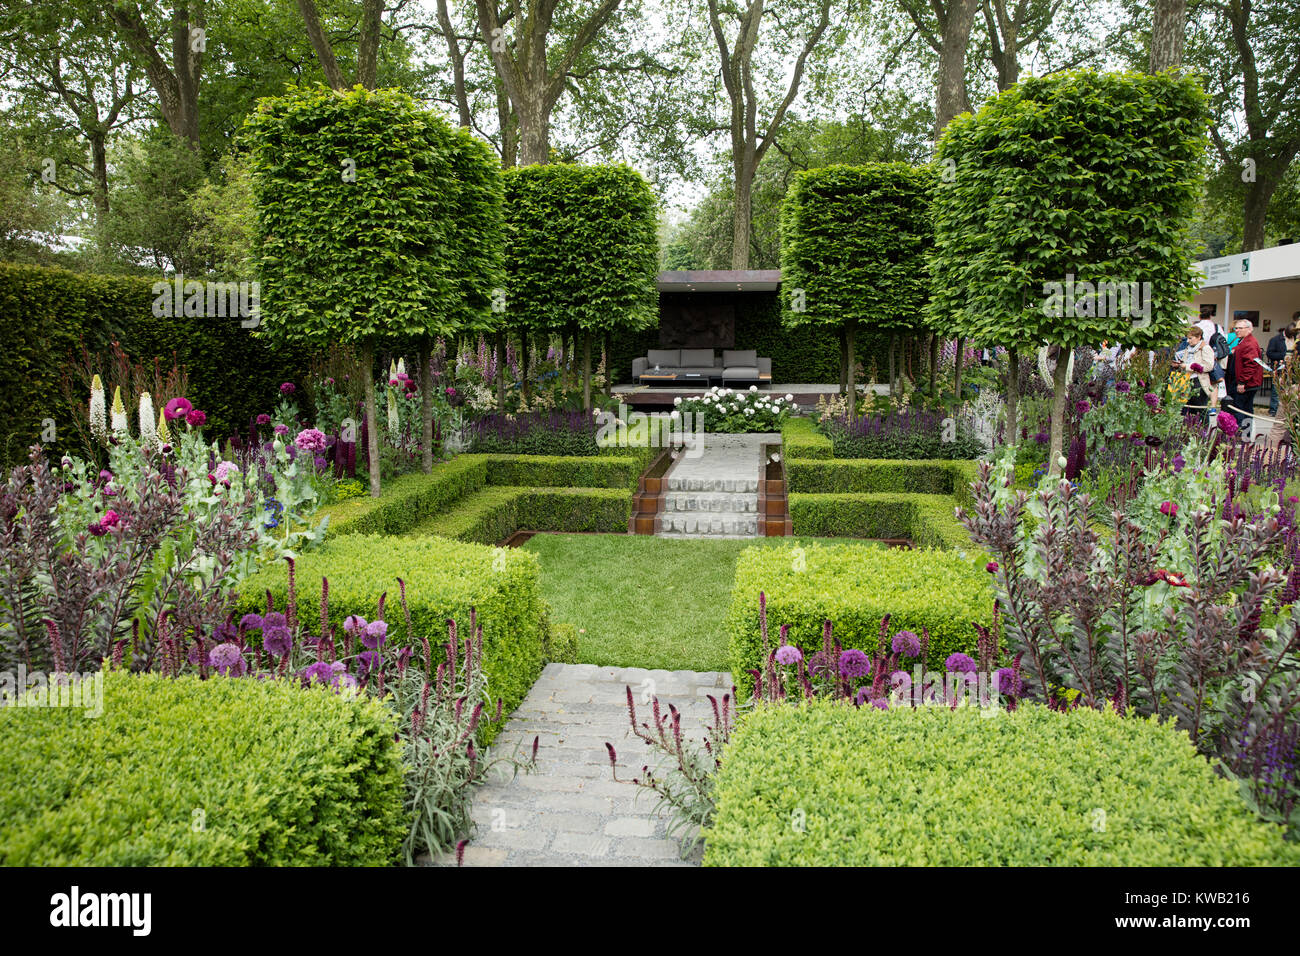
[706,0,833,269]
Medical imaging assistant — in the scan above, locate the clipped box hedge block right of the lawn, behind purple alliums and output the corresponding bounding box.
[727,544,993,700]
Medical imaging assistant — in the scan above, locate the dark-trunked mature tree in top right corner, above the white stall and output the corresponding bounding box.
[1187,0,1300,252]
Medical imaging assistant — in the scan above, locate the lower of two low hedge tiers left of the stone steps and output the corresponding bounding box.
[410,485,632,544]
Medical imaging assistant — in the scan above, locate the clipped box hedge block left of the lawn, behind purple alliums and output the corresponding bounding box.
[238,535,543,740]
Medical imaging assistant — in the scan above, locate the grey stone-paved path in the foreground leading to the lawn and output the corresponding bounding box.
[426,663,731,866]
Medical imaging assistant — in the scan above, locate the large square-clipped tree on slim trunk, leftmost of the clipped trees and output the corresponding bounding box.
[247,86,502,496]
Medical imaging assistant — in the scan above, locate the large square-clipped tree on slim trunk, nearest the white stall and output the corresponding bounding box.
[930,72,1208,473]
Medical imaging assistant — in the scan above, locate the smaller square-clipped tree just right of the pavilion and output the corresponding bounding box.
[781,163,933,419]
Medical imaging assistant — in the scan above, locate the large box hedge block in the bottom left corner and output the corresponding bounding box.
[0,671,408,866]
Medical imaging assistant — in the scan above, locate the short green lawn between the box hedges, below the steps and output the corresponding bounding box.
[524,535,883,671]
